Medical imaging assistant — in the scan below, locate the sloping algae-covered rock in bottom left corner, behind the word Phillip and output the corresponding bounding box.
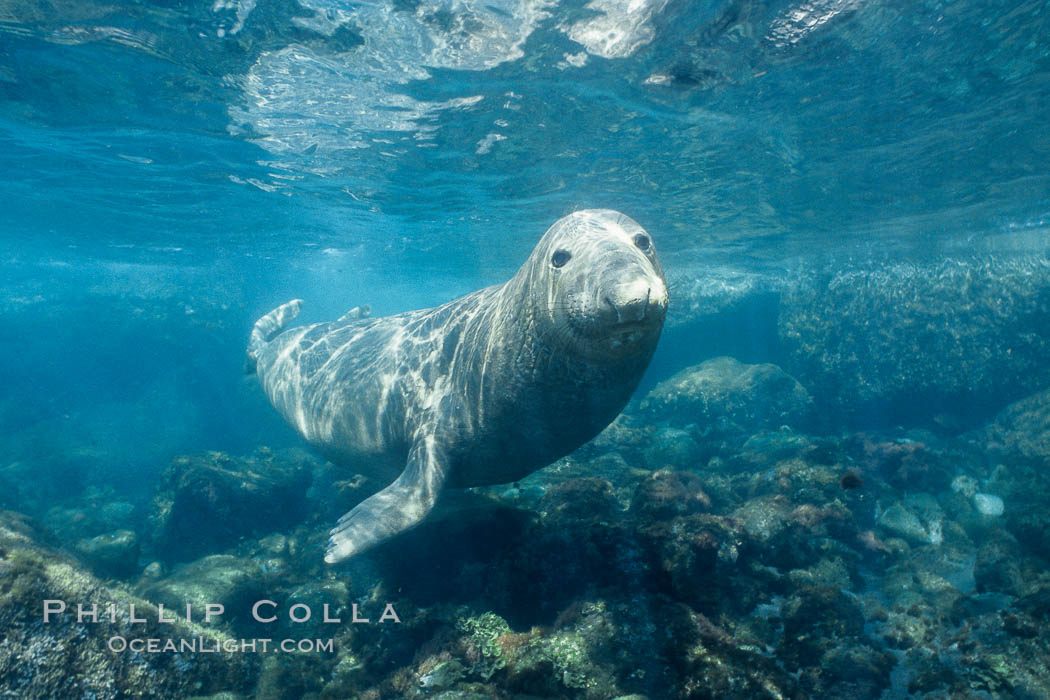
[0,511,256,700]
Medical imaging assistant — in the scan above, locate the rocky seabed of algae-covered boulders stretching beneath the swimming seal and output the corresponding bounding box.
[0,360,1050,700]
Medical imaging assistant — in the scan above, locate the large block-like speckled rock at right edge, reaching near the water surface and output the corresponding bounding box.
[778,258,1050,428]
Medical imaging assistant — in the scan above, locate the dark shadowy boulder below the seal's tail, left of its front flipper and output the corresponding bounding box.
[150,450,312,561]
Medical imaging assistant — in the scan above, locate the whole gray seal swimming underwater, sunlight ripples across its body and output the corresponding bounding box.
[248,210,668,564]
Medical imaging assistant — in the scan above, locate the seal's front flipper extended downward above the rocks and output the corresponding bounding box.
[324,434,446,564]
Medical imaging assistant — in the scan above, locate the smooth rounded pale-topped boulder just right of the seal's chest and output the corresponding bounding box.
[641,357,813,438]
